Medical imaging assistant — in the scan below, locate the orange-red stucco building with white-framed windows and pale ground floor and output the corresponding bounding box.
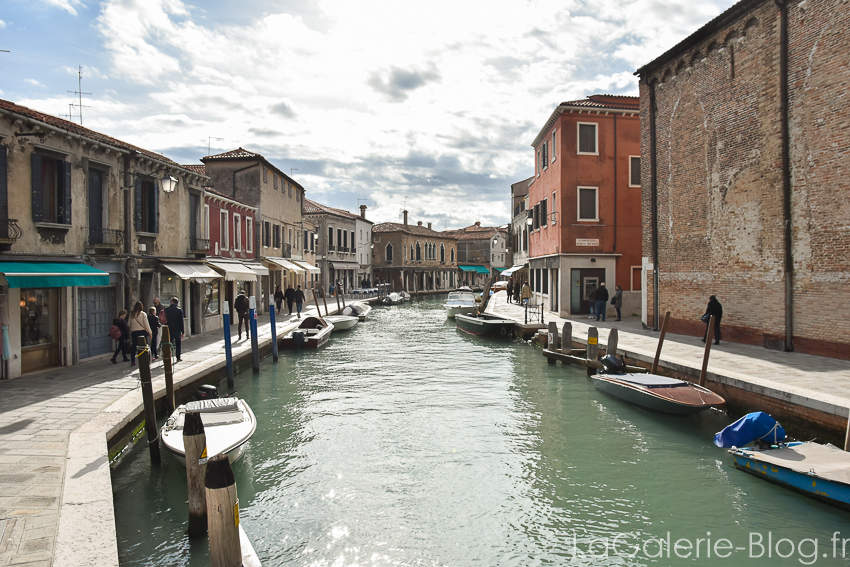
[528,95,641,316]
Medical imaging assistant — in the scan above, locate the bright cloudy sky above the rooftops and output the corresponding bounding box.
[0,0,733,229]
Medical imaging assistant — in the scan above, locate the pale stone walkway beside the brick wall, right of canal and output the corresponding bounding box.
[487,291,850,419]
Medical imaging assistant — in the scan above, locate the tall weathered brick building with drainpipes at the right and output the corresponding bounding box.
[637,0,850,359]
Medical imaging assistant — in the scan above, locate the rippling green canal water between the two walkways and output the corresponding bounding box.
[112,297,850,567]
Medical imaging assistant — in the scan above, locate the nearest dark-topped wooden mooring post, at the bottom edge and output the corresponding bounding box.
[204,455,237,567]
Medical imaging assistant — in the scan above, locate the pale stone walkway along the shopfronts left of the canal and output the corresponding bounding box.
[0,305,328,567]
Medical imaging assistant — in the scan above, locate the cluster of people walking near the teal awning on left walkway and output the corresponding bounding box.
[110,297,184,366]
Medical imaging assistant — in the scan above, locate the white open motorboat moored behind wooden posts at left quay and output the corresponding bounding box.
[159,398,257,467]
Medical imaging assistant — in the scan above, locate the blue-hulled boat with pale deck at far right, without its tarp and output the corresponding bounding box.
[729,442,850,510]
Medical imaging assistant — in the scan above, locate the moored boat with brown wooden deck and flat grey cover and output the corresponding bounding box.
[593,374,726,415]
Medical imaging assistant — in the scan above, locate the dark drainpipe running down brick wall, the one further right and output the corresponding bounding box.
[773,0,794,351]
